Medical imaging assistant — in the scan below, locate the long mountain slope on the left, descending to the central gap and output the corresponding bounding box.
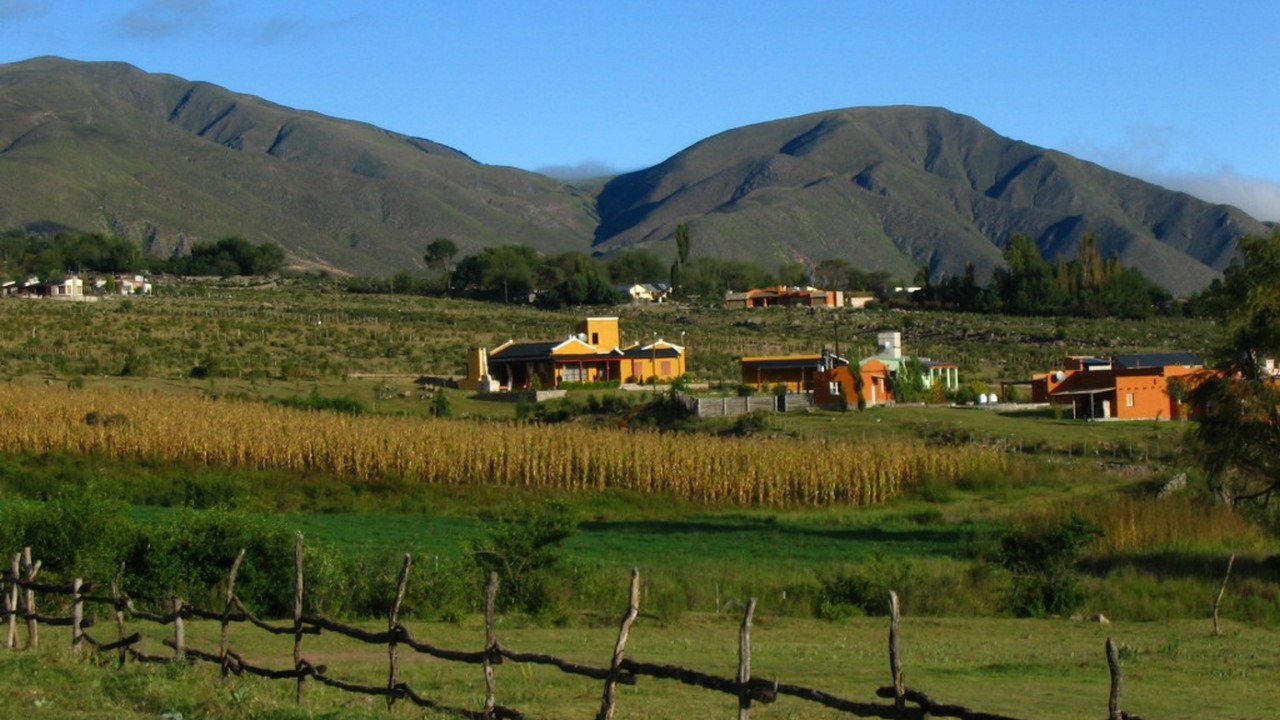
[0,58,595,274]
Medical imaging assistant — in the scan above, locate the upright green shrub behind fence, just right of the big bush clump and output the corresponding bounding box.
[471,501,577,615]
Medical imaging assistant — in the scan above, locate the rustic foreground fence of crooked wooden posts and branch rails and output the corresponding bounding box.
[0,533,1140,720]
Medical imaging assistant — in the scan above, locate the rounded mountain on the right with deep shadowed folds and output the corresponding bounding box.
[596,108,1267,292]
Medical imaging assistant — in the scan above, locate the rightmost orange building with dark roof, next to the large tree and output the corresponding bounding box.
[1032,352,1203,420]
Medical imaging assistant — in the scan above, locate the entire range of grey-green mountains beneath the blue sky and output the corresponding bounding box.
[0,58,1272,293]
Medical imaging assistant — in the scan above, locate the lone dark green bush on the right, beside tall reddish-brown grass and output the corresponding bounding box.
[996,512,1101,618]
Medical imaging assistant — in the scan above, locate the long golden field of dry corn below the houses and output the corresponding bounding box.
[0,383,1005,507]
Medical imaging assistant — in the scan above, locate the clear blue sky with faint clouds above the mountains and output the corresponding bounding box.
[0,0,1280,220]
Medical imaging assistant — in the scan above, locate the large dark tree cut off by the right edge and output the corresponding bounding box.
[1190,232,1280,505]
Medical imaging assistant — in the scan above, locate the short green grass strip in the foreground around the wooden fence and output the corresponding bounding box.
[0,609,1280,720]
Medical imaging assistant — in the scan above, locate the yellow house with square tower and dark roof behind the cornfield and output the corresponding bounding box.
[478,318,685,389]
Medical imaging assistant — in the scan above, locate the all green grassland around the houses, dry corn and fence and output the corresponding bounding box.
[0,286,1280,720]
